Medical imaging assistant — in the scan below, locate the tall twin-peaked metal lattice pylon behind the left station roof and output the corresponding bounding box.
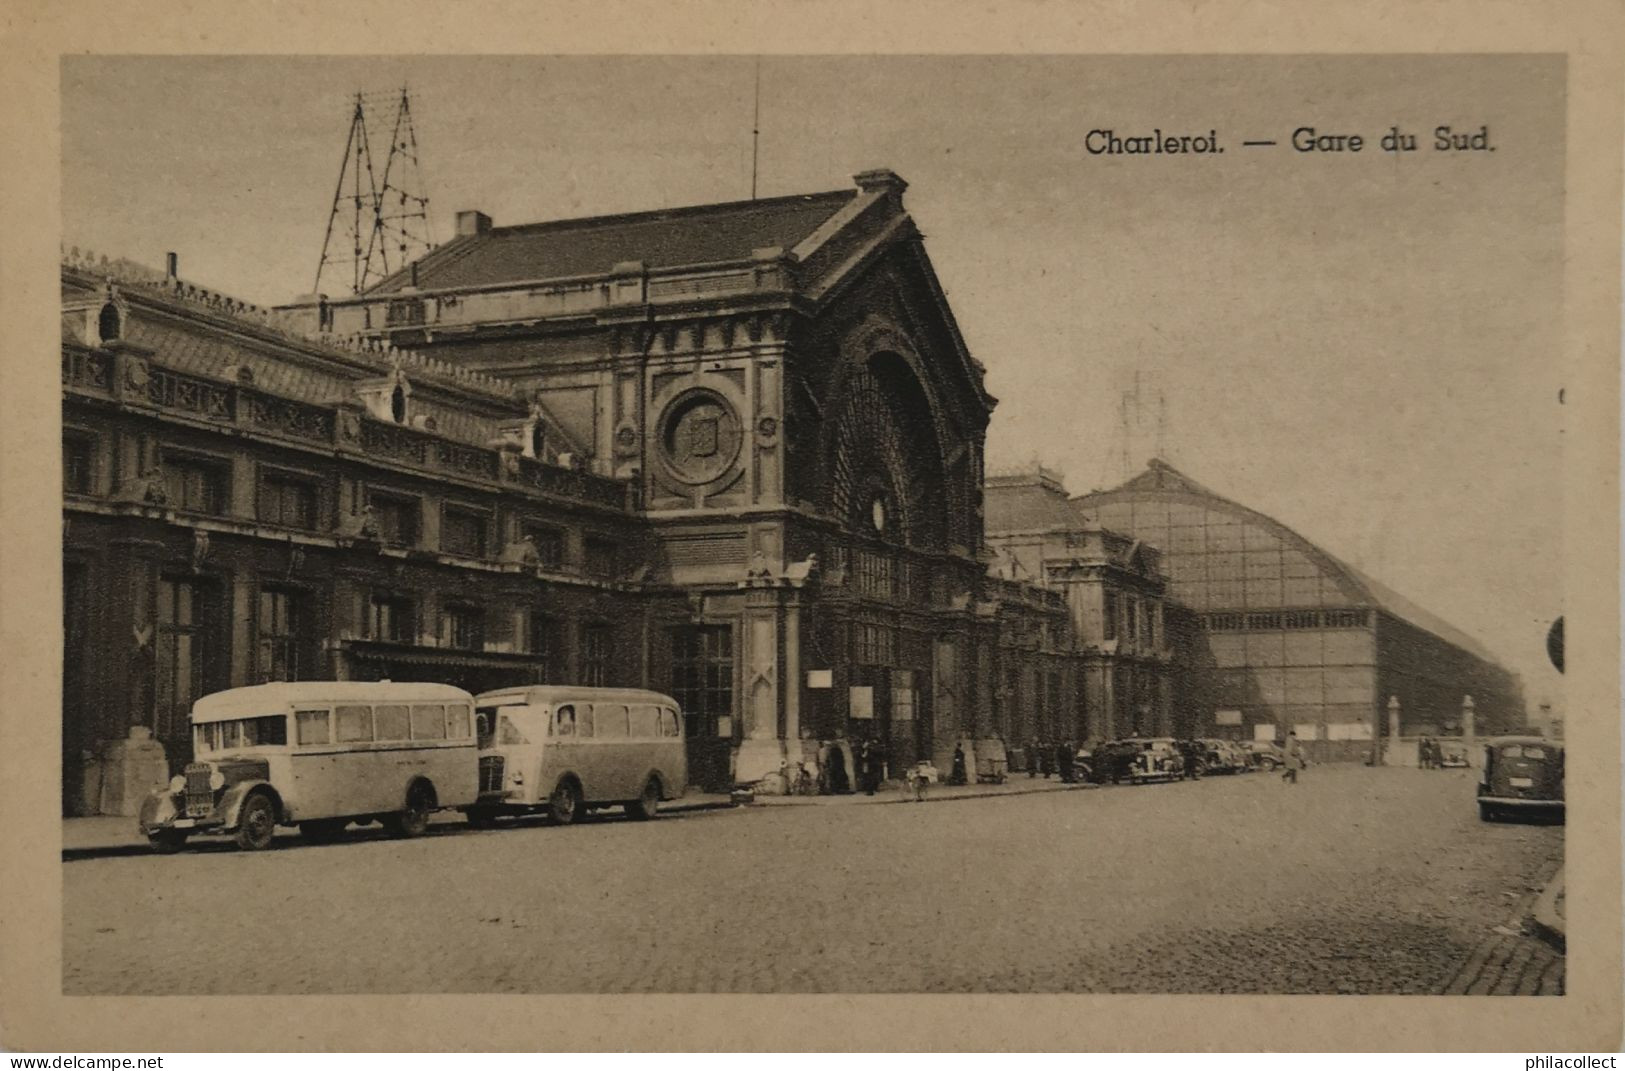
[314,86,434,294]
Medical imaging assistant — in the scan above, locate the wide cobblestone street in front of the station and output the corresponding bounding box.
[63,765,1563,995]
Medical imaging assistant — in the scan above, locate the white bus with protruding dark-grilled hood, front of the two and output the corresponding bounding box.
[140,681,478,852]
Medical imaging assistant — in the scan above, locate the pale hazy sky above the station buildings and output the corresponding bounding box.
[62,55,1565,709]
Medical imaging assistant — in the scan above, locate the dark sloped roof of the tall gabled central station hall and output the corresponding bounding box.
[367,189,858,294]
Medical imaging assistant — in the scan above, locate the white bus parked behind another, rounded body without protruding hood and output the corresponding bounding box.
[465,684,689,826]
